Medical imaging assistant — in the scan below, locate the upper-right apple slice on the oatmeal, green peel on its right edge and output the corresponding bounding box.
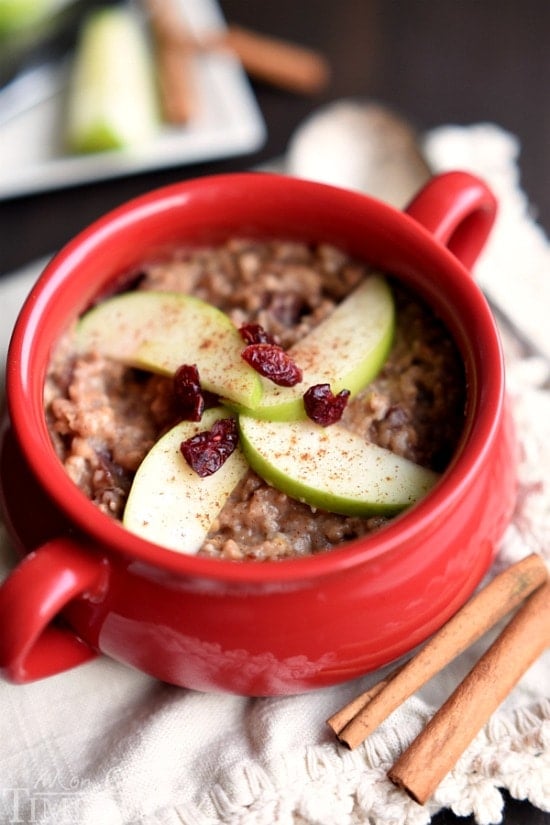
[235,275,395,421]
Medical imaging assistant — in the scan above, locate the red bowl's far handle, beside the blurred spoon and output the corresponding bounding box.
[405,172,497,270]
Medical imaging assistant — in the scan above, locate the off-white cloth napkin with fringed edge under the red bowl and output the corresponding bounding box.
[0,125,550,825]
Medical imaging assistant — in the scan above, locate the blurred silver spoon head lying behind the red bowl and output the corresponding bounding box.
[287,99,431,209]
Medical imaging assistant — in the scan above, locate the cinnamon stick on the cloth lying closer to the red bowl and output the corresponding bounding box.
[327,554,548,749]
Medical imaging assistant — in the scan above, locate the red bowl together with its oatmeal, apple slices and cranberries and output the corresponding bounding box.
[0,172,516,696]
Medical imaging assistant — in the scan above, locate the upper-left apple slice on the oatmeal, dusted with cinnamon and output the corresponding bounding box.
[76,291,262,407]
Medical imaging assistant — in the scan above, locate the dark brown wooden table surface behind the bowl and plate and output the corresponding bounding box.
[0,0,550,825]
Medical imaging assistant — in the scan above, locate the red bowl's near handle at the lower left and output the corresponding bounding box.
[0,538,107,684]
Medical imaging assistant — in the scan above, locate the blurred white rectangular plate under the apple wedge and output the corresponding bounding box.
[0,0,265,199]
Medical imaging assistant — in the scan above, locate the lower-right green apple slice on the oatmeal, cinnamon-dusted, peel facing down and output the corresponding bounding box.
[239,415,439,516]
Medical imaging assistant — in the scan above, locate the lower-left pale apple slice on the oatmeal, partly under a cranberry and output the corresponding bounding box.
[122,407,249,554]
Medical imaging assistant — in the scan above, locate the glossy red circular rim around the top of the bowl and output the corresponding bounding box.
[6,173,504,584]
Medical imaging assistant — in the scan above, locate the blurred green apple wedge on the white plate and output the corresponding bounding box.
[66,7,160,152]
